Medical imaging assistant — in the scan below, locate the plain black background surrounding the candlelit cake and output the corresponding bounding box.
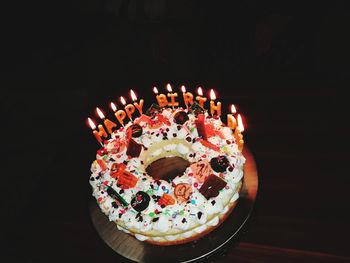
[0,0,350,262]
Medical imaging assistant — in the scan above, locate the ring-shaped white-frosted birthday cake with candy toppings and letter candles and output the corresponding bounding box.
[89,85,245,245]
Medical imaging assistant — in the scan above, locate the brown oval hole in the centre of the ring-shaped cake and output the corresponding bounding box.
[146,156,190,182]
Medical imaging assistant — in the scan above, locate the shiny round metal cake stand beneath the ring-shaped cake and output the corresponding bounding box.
[90,147,258,263]
